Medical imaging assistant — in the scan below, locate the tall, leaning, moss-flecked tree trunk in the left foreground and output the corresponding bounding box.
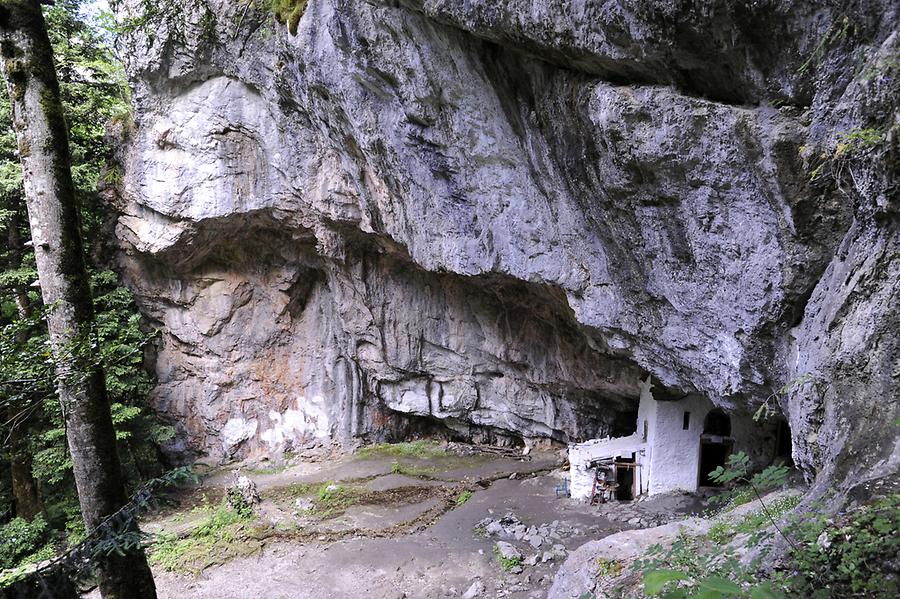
[0,0,156,599]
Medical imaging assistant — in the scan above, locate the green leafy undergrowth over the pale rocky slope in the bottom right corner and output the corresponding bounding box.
[617,454,900,599]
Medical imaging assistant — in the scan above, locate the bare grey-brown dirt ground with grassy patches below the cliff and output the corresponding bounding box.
[135,454,696,599]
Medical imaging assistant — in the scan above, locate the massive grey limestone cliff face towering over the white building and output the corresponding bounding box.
[109,0,900,482]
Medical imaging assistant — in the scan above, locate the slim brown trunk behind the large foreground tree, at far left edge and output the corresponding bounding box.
[7,197,44,520]
